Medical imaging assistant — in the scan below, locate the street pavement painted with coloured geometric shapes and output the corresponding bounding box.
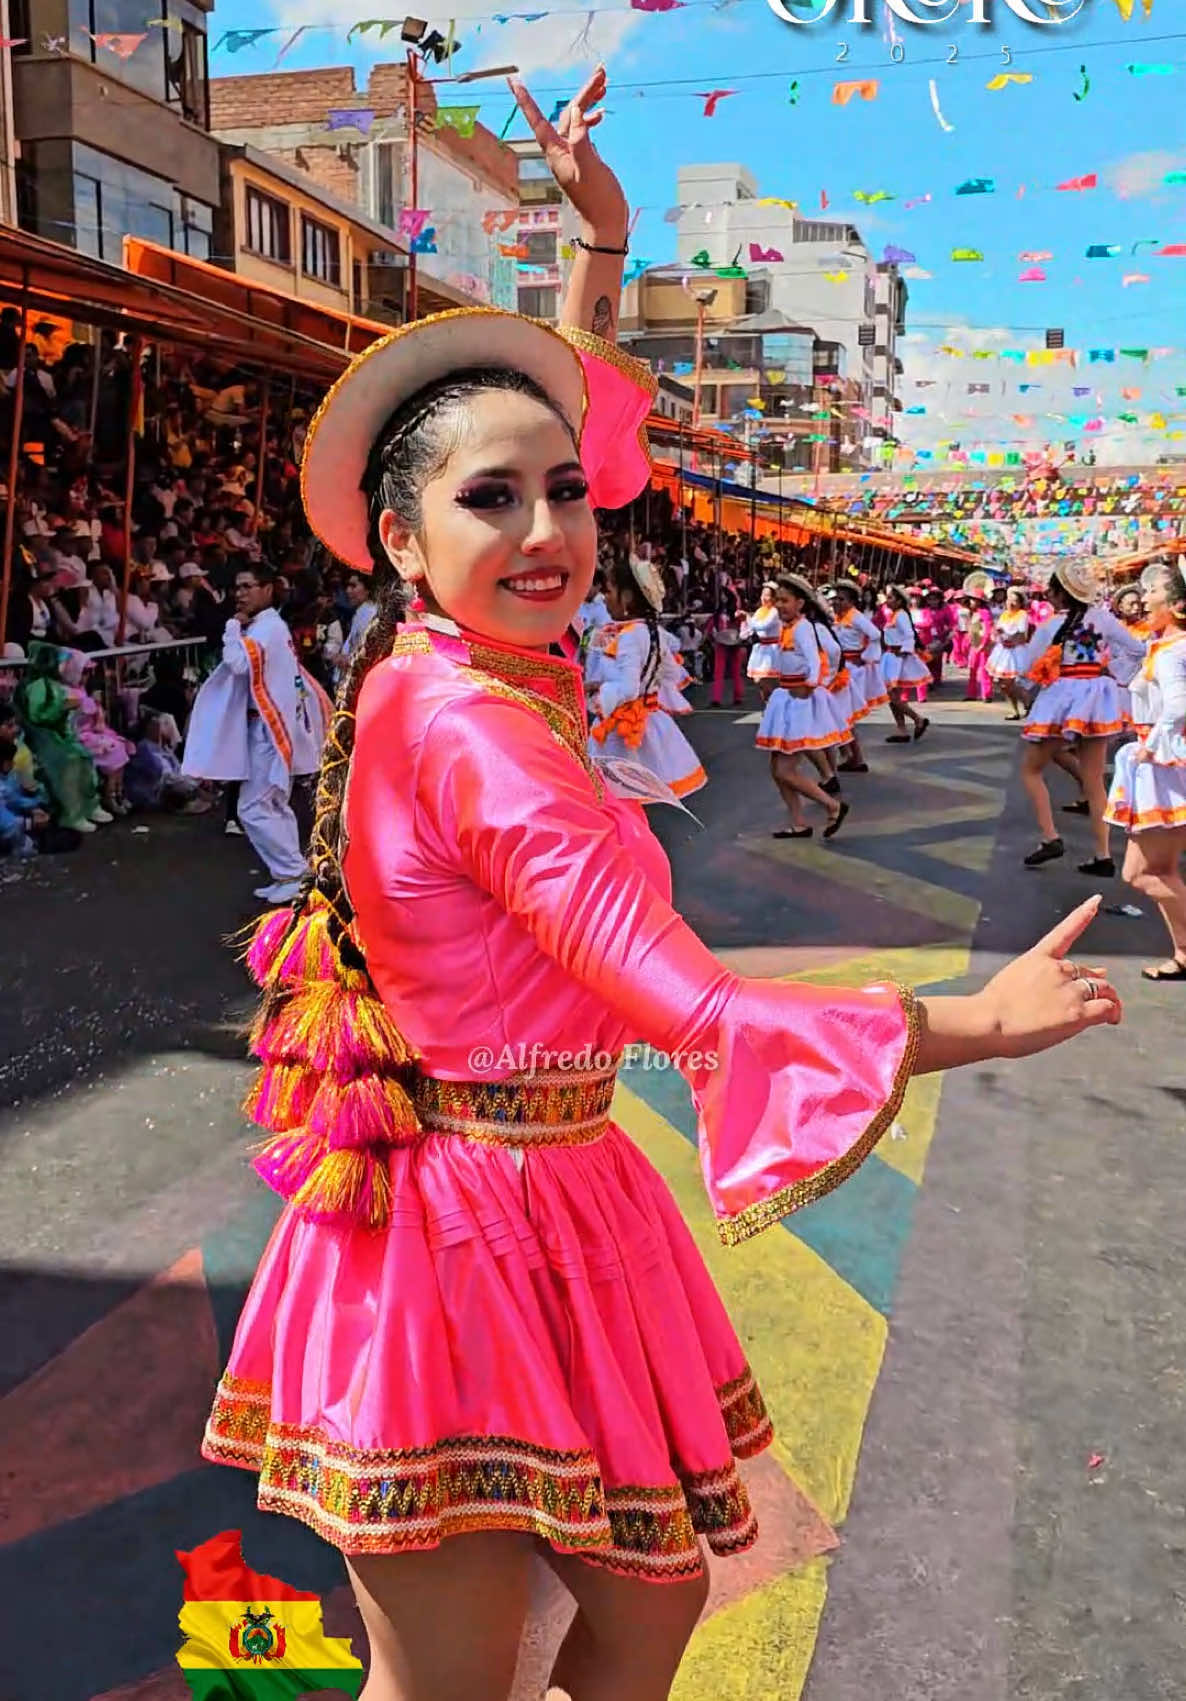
[0,680,1186,1701]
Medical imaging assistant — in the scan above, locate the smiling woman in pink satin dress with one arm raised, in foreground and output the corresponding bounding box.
[204,71,1121,1701]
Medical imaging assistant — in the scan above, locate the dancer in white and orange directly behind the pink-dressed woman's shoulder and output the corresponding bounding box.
[589,555,708,798]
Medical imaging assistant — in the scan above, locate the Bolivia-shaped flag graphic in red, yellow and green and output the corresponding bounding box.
[177,1529,362,1701]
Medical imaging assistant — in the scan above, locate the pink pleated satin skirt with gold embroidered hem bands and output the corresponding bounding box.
[202,1123,773,1582]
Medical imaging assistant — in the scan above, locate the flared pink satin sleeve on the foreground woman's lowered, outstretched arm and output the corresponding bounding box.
[417,699,917,1243]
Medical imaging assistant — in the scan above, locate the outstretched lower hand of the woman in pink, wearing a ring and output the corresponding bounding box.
[980,896,1125,1058]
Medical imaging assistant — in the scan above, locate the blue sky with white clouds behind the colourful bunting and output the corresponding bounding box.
[211,0,1186,459]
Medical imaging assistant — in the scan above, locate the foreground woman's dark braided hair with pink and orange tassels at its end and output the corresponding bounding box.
[236,367,575,1228]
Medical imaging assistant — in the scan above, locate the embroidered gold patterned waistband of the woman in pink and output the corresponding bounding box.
[413,1060,618,1146]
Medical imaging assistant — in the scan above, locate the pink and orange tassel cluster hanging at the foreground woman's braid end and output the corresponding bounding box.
[245,891,422,1228]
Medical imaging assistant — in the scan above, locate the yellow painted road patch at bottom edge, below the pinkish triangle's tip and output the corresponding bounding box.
[672,1556,827,1701]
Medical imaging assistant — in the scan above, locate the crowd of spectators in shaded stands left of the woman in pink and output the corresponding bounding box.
[0,331,371,856]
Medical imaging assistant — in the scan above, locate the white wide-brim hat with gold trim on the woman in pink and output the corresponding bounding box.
[301,308,587,573]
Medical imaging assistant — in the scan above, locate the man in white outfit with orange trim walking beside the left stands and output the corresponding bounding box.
[182,566,330,903]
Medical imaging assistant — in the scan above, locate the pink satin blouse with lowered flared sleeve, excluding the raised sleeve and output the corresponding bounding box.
[344,626,917,1242]
